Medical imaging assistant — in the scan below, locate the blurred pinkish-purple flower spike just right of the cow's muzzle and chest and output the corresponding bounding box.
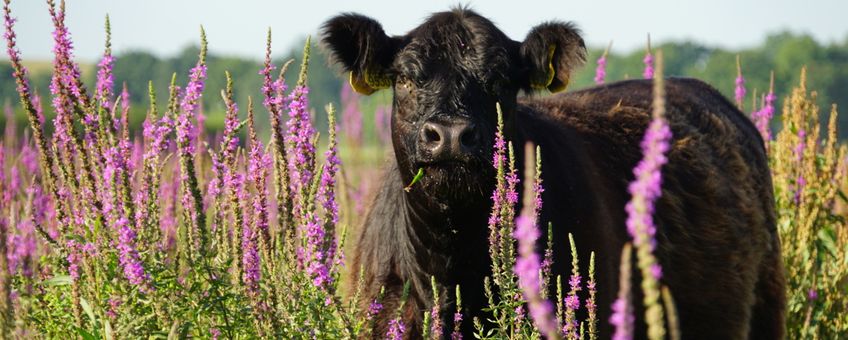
[514,143,560,339]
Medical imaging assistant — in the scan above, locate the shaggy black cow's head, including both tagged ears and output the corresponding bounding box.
[323,9,585,204]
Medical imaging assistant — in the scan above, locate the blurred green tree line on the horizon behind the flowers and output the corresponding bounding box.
[0,32,848,137]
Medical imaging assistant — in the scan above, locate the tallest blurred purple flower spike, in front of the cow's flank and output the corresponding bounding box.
[625,53,671,339]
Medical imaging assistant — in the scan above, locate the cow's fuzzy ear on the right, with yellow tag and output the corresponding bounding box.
[521,22,586,92]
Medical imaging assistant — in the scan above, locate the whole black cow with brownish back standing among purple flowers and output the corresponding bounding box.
[323,9,785,339]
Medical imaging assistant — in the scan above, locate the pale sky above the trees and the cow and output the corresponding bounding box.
[12,0,848,61]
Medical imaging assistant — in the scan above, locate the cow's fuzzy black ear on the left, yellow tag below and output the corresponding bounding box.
[322,13,398,95]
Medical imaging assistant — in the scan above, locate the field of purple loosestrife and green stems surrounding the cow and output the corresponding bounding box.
[0,0,848,339]
